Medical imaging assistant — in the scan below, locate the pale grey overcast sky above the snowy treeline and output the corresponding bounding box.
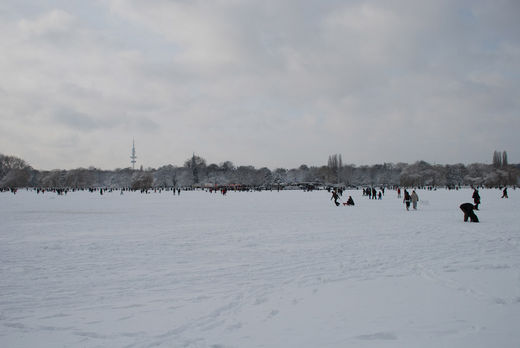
[0,0,520,169]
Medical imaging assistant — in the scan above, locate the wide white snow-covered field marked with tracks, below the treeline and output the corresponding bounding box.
[0,189,520,348]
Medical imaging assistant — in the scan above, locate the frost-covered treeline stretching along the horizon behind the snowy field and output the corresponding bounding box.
[0,154,520,189]
